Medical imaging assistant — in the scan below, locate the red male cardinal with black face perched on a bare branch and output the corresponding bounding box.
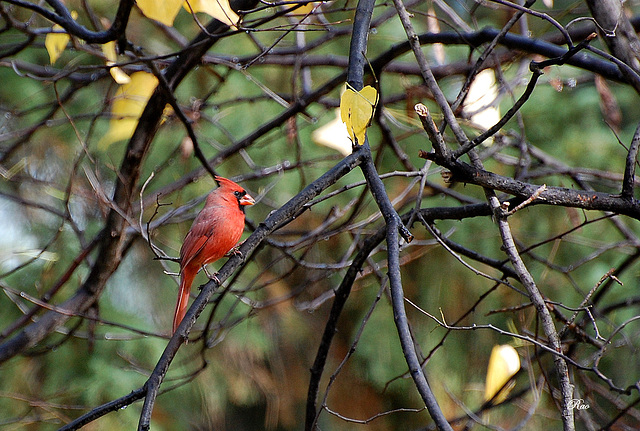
[173,176,255,333]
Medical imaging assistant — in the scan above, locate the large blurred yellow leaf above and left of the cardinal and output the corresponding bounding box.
[98,72,158,149]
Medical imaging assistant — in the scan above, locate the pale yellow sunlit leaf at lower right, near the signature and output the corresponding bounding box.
[484,344,520,404]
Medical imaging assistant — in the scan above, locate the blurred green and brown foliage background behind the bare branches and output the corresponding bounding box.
[0,1,640,430]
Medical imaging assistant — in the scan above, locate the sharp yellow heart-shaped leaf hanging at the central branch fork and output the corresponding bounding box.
[340,84,378,145]
